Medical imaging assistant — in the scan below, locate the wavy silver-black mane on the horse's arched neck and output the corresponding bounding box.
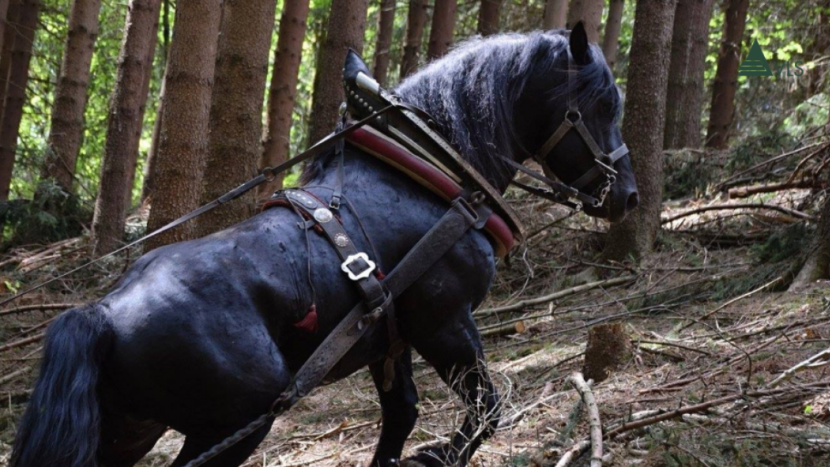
[301,30,619,187]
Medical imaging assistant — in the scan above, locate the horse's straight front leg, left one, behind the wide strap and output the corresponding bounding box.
[369,347,418,467]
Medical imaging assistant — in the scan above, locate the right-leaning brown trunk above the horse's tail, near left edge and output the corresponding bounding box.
[42,0,101,193]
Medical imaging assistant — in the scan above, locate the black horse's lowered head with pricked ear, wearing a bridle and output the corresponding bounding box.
[514,23,639,222]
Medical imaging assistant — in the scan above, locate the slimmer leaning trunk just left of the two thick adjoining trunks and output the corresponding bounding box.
[92,0,161,255]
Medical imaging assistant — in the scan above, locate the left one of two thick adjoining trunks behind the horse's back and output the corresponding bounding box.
[145,0,222,251]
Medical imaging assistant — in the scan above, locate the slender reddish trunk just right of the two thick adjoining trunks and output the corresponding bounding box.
[259,0,309,196]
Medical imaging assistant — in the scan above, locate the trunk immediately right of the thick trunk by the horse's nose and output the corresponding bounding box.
[663,0,711,149]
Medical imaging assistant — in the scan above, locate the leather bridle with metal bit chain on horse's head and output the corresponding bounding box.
[503,53,628,210]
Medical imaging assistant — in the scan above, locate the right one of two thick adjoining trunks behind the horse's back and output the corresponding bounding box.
[196,0,282,237]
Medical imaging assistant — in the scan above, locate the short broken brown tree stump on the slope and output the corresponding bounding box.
[582,323,632,383]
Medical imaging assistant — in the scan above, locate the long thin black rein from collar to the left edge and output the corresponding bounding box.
[0,105,396,306]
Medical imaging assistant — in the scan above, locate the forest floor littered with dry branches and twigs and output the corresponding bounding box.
[0,176,830,467]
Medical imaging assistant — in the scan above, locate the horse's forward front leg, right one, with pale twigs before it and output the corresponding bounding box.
[407,312,501,467]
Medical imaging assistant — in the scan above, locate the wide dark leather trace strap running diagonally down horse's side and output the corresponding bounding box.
[179,197,490,467]
